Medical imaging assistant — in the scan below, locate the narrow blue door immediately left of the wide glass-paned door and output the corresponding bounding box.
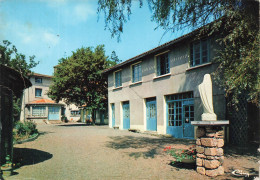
[146,98,157,131]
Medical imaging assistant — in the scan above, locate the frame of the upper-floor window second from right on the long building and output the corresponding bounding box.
[154,50,171,77]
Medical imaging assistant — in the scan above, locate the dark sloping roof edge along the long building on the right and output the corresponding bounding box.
[103,28,201,73]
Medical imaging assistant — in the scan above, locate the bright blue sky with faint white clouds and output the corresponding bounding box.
[0,0,188,75]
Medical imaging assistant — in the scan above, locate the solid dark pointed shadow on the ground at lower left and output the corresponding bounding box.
[13,148,53,166]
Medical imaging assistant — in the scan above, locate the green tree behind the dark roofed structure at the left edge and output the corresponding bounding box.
[0,40,39,120]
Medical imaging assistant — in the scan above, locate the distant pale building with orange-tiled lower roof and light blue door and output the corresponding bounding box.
[20,73,80,122]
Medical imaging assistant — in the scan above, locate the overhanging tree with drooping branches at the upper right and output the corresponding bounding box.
[98,0,260,105]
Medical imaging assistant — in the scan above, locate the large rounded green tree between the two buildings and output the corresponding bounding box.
[48,45,116,123]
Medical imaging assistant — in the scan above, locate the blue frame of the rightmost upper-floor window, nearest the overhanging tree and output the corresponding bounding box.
[189,38,211,68]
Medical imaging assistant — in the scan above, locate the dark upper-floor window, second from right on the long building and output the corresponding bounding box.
[156,53,170,76]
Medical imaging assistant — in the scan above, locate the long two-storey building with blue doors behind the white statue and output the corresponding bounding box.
[103,30,226,139]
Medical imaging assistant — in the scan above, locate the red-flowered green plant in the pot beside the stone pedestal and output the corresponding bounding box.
[164,146,196,164]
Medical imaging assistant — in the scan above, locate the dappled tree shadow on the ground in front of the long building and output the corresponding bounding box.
[106,136,195,159]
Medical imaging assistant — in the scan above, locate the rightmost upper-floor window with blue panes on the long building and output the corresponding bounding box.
[190,39,209,66]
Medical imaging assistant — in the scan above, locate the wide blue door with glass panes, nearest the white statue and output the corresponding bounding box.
[166,92,194,139]
